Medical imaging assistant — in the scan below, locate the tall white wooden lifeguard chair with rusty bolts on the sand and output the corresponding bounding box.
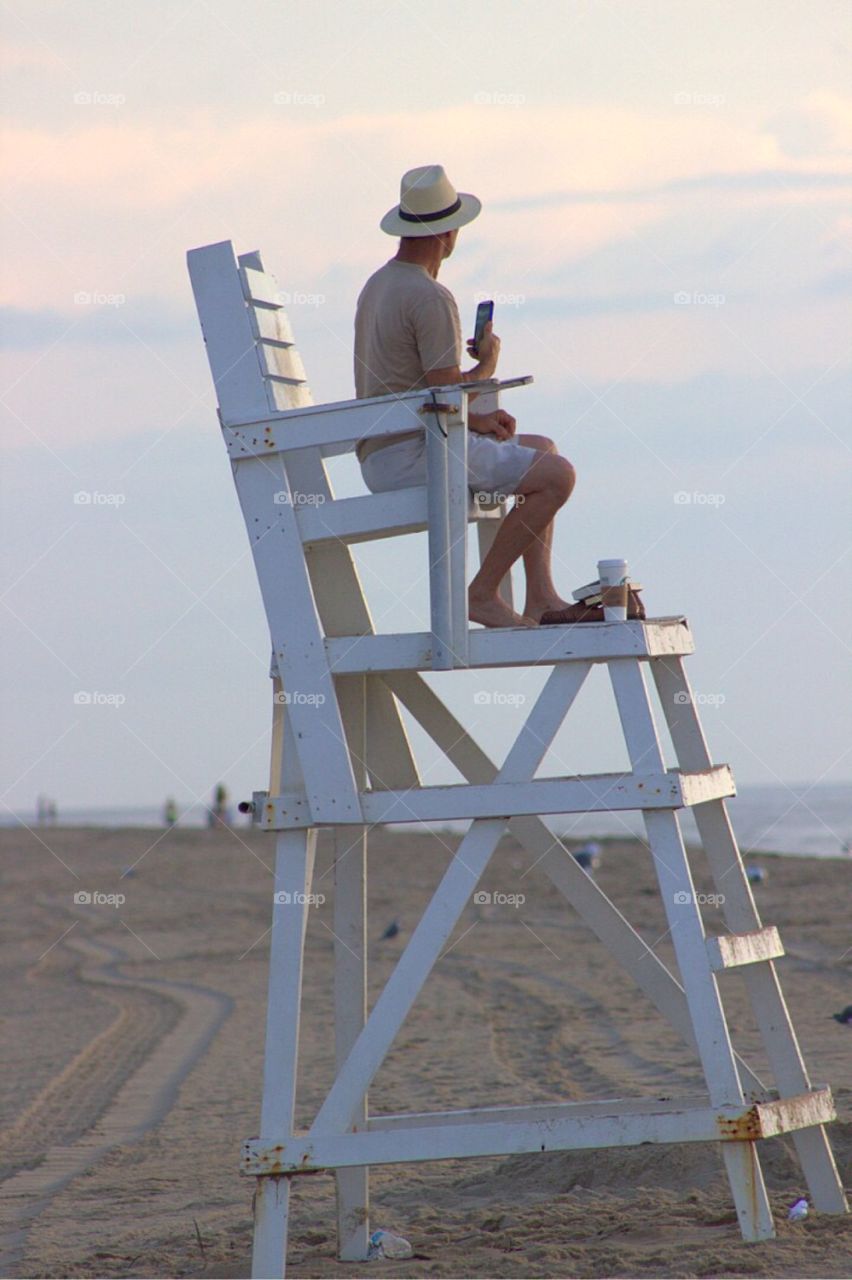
[188,241,847,1277]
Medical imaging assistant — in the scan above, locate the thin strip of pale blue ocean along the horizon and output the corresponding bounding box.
[0,783,852,858]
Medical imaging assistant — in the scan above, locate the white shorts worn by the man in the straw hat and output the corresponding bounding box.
[361,431,541,500]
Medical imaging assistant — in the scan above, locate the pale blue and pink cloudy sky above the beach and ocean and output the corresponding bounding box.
[0,0,852,814]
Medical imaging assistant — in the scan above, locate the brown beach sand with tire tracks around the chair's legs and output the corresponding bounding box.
[0,829,852,1277]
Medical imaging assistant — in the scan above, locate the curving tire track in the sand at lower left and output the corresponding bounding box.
[0,937,233,1275]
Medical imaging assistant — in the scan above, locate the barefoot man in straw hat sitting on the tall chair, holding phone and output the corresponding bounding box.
[354,165,645,627]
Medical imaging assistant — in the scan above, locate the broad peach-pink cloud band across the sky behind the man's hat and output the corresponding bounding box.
[0,99,840,306]
